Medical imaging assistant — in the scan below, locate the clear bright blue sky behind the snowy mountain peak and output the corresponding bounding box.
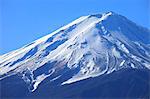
[0,0,150,55]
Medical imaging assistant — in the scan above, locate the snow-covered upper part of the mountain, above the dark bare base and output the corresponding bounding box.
[0,12,150,91]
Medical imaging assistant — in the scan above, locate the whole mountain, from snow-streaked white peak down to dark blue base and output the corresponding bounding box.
[0,12,150,99]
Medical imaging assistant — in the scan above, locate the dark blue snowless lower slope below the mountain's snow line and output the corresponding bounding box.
[1,68,150,99]
